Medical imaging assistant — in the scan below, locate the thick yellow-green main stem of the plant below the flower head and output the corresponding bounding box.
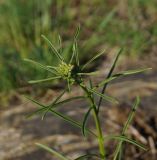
[79,83,106,160]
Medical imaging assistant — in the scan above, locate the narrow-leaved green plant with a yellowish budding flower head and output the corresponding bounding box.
[25,27,150,160]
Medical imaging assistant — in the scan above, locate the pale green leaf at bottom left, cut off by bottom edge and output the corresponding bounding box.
[35,143,69,160]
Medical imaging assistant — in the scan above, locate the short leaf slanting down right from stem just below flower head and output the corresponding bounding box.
[88,88,118,103]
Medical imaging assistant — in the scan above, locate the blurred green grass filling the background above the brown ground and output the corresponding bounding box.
[0,0,157,91]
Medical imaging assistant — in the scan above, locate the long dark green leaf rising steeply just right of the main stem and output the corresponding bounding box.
[97,49,123,113]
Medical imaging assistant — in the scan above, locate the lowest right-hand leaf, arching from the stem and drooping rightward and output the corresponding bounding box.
[104,135,148,151]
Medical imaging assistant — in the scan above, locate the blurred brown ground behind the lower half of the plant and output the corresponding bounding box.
[0,49,157,160]
